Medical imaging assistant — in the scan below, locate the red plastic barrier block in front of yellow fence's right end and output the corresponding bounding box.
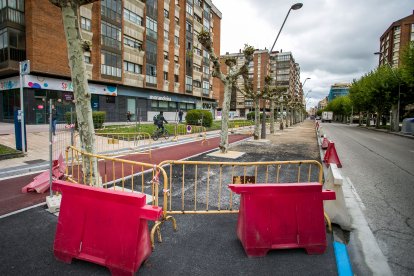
[229,182,335,257]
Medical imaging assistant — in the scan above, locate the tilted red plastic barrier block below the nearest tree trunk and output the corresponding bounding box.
[52,181,162,275]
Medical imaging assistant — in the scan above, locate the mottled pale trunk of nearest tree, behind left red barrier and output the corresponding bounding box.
[49,0,99,185]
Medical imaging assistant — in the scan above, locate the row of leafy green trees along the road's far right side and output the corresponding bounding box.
[320,42,414,131]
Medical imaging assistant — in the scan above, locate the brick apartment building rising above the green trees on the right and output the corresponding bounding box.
[379,11,414,68]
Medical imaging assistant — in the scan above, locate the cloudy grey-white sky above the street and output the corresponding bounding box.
[213,0,414,107]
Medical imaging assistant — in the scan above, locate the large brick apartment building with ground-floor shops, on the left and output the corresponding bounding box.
[0,0,221,124]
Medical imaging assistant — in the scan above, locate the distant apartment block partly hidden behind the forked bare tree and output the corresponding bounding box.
[219,49,303,117]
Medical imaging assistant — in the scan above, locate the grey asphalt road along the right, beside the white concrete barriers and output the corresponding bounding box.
[322,123,414,275]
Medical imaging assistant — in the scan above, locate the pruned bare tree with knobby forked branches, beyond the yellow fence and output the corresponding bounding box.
[198,31,254,153]
